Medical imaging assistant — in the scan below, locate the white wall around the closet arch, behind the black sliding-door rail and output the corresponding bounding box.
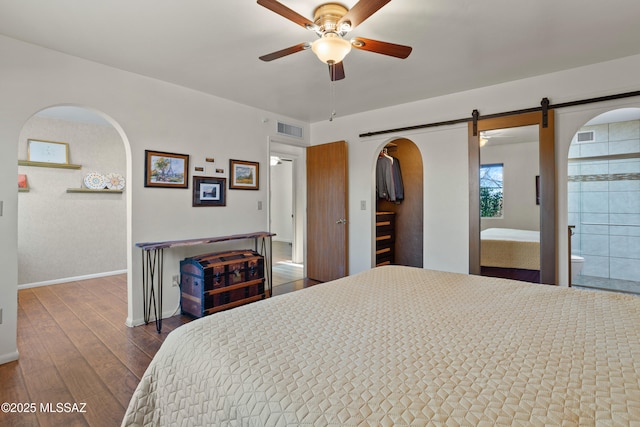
[311,56,640,284]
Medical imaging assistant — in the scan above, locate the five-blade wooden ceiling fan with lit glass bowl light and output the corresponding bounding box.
[258,0,412,81]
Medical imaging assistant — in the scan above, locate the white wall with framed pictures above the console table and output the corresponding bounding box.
[0,37,309,363]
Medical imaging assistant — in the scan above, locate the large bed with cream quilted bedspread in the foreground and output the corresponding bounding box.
[122,266,640,426]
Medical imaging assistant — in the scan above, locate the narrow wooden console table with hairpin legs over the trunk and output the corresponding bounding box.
[136,231,275,333]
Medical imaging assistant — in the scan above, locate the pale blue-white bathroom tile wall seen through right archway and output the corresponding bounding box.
[568,120,640,281]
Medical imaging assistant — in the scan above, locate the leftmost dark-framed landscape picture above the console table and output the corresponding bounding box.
[144,150,189,188]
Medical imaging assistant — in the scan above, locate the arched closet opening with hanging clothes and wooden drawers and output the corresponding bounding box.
[374,138,424,267]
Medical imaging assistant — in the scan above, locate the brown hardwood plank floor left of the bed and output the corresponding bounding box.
[0,275,318,427]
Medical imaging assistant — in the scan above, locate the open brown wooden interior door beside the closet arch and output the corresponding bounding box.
[307,141,349,282]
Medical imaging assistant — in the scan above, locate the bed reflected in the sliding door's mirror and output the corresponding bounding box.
[480,228,540,283]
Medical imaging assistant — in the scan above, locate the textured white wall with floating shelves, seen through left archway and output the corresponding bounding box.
[18,105,130,288]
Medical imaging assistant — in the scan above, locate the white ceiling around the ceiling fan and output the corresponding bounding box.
[0,0,640,122]
